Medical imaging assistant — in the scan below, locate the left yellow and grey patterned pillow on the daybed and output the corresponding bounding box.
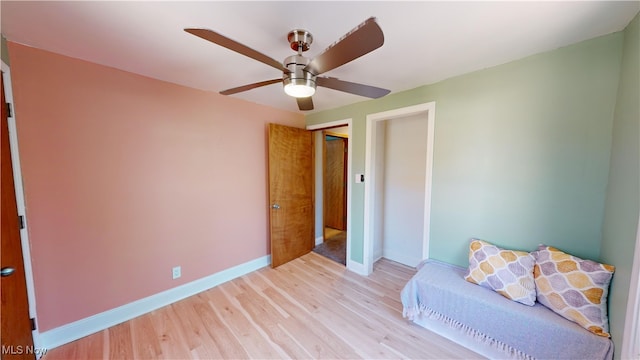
[465,239,536,306]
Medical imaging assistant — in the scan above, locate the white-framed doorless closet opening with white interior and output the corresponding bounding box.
[363,102,435,275]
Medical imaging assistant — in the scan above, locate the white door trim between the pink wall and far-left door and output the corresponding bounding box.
[1,61,42,356]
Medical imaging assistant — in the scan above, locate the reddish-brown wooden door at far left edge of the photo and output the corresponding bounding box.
[0,71,35,359]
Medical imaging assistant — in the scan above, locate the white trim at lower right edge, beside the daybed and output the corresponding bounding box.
[621,216,640,360]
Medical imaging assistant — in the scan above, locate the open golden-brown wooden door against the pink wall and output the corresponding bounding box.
[269,124,315,267]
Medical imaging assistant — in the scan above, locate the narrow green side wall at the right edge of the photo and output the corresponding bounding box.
[600,11,640,358]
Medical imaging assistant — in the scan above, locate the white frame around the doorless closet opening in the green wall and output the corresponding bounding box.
[363,101,436,275]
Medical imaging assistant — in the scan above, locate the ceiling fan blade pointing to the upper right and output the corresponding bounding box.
[305,17,384,75]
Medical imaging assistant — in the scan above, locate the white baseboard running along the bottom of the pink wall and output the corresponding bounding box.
[38,255,271,349]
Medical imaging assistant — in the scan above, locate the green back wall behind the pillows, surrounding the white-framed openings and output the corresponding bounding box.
[306,32,623,266]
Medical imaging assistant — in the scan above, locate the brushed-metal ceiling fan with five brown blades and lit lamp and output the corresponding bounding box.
[184,17,390,110]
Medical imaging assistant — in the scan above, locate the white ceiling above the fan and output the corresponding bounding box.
[0,0,640,113]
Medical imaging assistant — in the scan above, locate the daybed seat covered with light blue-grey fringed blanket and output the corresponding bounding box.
[401,260,613,360]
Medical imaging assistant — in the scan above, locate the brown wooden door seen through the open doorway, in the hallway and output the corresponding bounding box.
[323,135,347,230]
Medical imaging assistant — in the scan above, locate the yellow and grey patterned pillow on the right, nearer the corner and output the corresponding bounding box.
[533,245,615,337]
